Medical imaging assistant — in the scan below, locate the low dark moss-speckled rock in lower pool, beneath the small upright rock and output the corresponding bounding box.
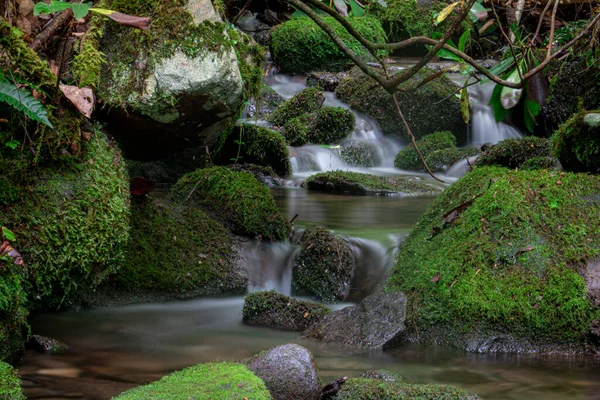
[242,290,329,331]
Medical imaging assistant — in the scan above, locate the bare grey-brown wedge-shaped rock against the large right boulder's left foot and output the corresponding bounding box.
[302,292,406,349]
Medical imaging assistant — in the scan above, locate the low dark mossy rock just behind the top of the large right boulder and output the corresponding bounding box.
[475,136,551,168]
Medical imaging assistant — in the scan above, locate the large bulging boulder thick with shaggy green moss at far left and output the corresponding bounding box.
[0,132,130,307]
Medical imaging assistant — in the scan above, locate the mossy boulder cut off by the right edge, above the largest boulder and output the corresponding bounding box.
[551,111,600,173]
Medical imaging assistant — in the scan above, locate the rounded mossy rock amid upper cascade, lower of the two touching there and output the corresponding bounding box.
[283,106,356,146]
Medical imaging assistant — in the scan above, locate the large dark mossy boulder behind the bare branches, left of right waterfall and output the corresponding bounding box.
[335,67,467,143]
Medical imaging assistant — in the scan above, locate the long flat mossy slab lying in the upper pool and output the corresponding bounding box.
[306,171,438,196]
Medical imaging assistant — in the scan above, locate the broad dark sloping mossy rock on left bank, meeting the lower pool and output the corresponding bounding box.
[111,198,246,295]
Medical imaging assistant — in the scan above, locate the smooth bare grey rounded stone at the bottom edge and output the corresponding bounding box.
[245,344,321,400]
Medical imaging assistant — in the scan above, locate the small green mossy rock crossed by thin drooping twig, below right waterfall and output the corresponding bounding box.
[394,131,456,171]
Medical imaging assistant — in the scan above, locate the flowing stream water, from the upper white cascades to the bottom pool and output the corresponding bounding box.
[18,68,600,400]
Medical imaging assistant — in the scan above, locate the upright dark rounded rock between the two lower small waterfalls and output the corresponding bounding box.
[292,226,354,303]
